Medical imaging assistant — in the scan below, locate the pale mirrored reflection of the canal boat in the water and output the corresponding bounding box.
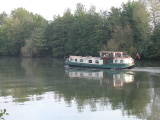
[65,68,134,87]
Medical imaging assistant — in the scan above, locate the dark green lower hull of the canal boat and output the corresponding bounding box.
[65,62,134,69]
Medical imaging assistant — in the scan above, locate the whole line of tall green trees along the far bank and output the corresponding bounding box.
[0,0,160,59]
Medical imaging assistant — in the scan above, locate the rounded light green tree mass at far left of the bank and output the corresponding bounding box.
[0,8,47,56]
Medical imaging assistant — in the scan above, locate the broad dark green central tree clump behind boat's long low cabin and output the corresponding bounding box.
[46,4,105,57]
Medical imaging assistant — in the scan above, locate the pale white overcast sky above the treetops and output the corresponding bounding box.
[0,0,128,20]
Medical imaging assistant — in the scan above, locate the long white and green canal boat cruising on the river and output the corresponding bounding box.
[65,51,135,69]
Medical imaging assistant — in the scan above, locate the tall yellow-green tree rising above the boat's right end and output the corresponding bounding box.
[122,2,150,53]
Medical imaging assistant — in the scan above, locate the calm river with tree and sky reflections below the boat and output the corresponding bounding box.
[0,58,160,120]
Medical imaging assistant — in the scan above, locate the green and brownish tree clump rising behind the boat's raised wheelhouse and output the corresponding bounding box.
[107,2,149,55]
